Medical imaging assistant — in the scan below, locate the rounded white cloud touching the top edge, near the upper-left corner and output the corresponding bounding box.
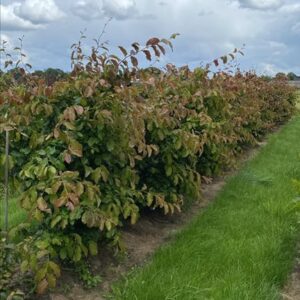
[14,0,65,24]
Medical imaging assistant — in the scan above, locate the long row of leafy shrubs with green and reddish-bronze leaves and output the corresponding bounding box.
[0,38,295,293]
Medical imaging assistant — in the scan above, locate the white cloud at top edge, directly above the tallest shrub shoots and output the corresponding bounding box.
[71,0,137,20]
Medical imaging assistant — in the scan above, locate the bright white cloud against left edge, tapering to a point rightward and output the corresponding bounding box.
[0,3,41,30]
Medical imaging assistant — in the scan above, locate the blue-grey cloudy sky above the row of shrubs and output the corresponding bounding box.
[0,0,300,75]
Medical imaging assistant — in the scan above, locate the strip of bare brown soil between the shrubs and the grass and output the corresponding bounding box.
[44,142,262,300]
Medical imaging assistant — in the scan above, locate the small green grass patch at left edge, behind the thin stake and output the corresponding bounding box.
[0,186,26,229]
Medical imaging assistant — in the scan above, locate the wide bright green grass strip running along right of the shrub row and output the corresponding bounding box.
[109,116,300,300]
